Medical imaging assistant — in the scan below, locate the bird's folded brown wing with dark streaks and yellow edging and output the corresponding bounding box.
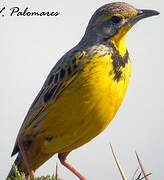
[11,51,85,156]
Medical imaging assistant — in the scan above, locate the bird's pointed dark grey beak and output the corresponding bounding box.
[128,9,160,25]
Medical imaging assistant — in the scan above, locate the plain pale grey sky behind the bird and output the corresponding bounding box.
[0,0,164,180]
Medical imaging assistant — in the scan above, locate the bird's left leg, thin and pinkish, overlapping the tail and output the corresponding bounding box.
[18,138,35,179]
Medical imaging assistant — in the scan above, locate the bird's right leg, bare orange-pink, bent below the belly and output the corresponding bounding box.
[58,153,86,180]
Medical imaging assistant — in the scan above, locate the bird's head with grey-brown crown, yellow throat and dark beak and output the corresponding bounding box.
[85,2,159,56]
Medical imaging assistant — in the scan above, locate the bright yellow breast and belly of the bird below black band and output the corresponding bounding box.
[43,54,130,153]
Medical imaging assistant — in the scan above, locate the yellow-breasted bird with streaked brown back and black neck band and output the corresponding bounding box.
[8,2,159,180]
